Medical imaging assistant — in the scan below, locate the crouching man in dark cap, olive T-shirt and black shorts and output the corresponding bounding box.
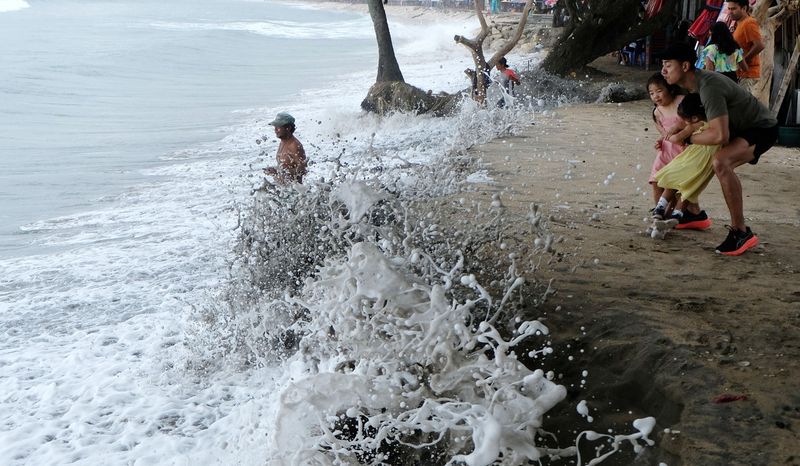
[661,43,778,256]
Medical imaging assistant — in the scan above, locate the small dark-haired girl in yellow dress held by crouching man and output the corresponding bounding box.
[653,94,720,220]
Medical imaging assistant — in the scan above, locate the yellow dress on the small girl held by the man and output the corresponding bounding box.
[655,123,720,204]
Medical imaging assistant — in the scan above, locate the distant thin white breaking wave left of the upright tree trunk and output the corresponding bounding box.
[151,17,373,40]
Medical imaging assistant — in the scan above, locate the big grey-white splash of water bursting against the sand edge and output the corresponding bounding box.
[189,102,647,465]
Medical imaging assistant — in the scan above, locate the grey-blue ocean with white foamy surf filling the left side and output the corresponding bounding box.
[0,0,664,465]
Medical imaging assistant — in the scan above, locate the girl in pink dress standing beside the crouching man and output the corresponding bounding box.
[647,73,684,207]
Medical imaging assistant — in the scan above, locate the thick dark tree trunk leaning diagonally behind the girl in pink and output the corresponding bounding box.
[542,0,677,76]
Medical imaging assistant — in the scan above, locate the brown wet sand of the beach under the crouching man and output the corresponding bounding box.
[471,58,800,466]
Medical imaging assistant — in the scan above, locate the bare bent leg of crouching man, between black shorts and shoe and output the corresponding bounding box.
[714,138,755,231]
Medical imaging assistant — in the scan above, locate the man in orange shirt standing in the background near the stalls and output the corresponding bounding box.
[728,0,764,93]
